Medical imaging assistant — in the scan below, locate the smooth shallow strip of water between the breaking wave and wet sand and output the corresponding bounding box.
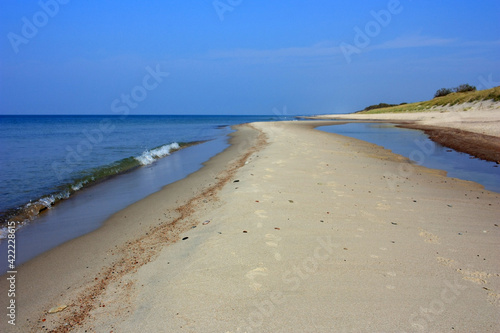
[0,135,234,275]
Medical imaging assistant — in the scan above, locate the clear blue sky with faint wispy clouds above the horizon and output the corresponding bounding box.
[0,0,500,115]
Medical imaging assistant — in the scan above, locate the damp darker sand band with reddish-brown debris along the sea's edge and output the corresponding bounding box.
[0,125,272,332]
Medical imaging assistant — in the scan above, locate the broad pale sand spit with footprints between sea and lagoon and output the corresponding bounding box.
[0,122,500,332]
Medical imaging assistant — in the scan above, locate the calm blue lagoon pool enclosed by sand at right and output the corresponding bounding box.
[319,123,500,192]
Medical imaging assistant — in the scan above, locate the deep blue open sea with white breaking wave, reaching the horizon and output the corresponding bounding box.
[0,116,286,228]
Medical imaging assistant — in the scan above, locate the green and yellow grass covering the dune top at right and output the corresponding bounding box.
[357,86,500,114]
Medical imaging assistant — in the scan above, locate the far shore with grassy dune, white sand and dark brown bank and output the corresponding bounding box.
[304,87,500,163]
